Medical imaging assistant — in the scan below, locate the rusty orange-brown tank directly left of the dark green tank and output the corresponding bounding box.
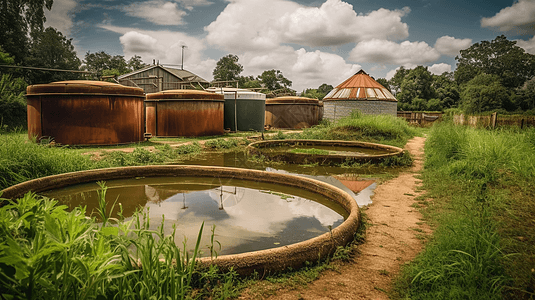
[145,90,225,137]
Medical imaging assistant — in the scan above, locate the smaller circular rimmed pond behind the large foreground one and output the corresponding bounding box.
[247,140,403,164]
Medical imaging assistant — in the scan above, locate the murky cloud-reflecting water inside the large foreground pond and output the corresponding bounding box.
[43,177,345,255]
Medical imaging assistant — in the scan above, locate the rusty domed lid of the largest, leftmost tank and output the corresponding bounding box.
[26,80,145,96]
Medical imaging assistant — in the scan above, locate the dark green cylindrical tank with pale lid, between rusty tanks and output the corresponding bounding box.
[207,88,266,131]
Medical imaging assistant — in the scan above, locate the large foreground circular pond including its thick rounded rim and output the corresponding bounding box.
[2,166,360,274]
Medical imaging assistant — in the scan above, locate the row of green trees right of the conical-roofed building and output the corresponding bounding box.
[377,35,535,114]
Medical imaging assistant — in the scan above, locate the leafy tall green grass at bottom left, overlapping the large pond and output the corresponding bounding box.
[0,183,236,299]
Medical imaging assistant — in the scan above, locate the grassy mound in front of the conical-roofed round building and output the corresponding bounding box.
[300,112,417,146]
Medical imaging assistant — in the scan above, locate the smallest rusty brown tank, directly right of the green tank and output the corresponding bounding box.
[266,96,323,129]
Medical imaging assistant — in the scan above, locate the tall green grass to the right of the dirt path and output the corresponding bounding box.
[396,123,535,299]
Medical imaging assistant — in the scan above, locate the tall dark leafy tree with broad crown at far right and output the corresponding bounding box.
[455,35,535,88]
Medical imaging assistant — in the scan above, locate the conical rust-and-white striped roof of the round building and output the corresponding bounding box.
[323,70,397,102]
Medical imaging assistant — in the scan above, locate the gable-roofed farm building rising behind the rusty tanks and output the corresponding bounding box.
[117,65,209,93]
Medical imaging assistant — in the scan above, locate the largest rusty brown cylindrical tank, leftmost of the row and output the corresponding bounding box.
[26,80,145,145]
